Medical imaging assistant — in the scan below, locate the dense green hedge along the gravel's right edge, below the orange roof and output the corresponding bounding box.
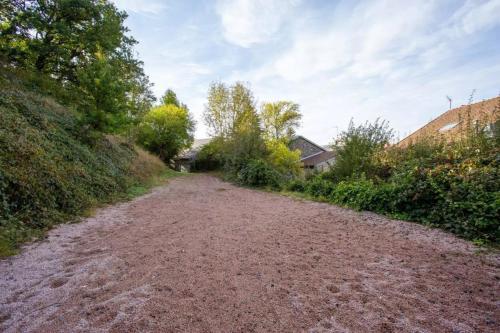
[287,116,500,243]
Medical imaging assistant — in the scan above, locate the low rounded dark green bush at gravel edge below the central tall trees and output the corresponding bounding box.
[237,160,282,188]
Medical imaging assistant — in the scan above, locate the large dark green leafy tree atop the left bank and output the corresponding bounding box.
[0,0,154,132]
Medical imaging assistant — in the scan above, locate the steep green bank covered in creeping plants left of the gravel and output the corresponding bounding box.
[0,73,175,257]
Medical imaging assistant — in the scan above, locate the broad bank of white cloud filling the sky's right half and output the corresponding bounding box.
[231,0,500,143]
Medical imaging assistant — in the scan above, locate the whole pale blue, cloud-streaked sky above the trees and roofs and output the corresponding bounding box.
[114,0,500,144]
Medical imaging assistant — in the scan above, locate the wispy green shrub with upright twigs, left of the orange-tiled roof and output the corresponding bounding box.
[329,120,393,181]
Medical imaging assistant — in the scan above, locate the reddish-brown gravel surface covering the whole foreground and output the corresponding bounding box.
[0,175,500,332]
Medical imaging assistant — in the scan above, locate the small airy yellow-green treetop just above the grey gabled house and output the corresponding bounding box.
[260,101,302,141]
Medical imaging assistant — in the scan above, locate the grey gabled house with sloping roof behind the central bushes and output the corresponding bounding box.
[289,135,335,172]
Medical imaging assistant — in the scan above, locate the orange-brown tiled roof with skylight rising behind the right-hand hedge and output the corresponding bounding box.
[397,97,500,147]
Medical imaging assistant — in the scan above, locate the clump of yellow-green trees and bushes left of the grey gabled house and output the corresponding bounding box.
[200,83,302,186]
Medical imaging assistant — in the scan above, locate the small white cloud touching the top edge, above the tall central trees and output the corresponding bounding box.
[216,0,299,48]
